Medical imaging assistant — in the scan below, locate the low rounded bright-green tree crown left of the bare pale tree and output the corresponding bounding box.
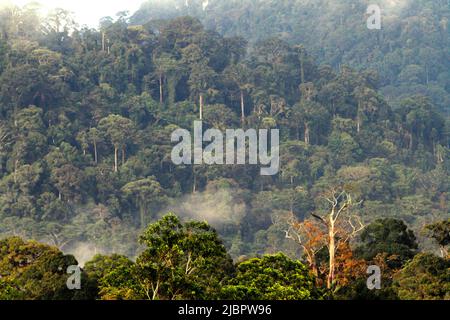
[222,253,321,300]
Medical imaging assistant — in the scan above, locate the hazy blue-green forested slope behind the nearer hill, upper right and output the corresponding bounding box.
[131,0,450,115]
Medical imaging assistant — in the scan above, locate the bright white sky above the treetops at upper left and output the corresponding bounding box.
[0,0,145,27]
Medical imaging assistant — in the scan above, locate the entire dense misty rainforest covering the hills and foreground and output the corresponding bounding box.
[0,0,450,300]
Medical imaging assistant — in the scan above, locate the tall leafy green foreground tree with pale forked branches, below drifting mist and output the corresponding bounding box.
[135,214,234,300]
